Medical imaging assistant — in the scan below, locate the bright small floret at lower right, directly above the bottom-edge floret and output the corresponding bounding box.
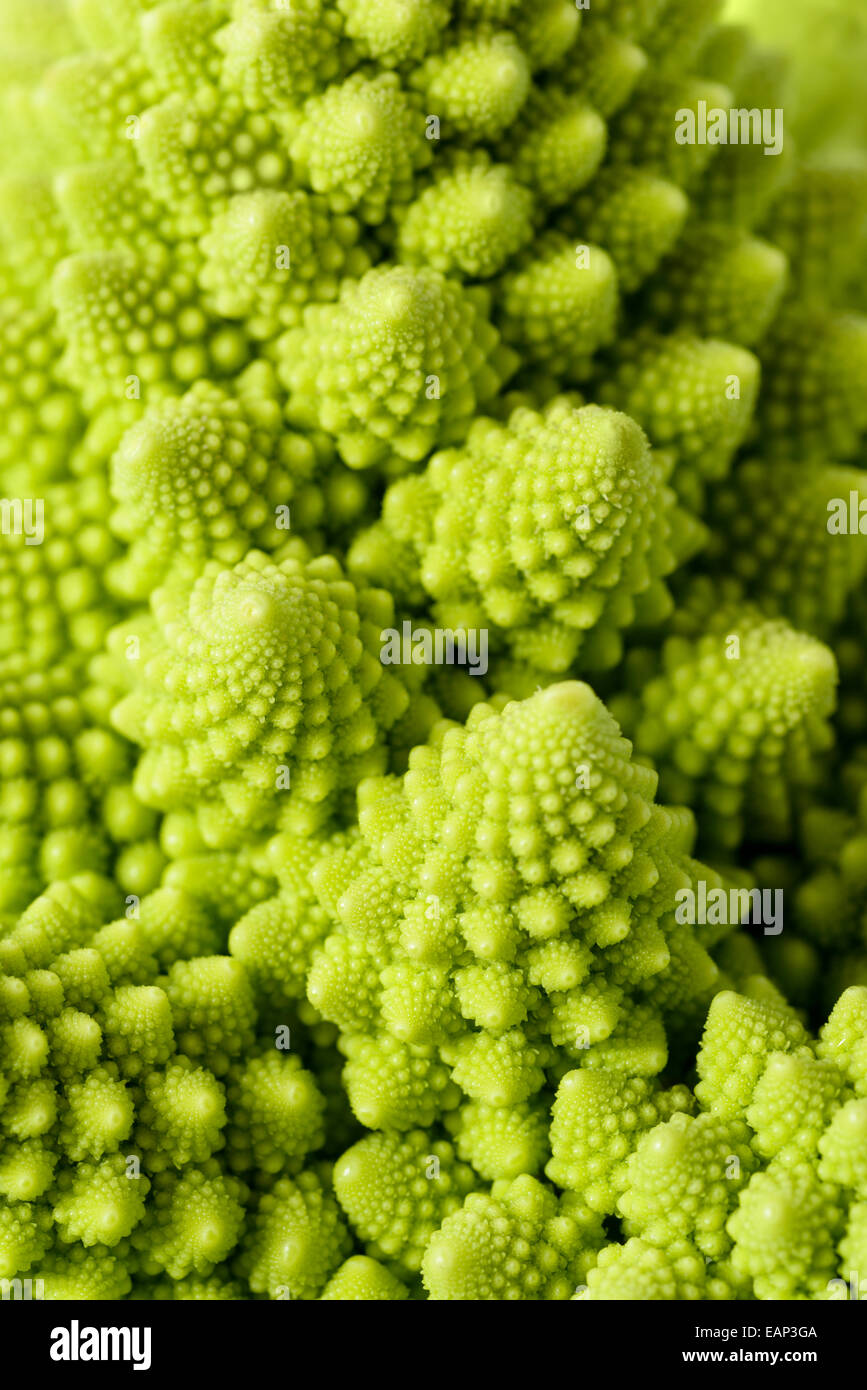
[745,1049,843,1176]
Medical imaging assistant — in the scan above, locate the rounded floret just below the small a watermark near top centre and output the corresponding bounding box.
[396,152,535,279]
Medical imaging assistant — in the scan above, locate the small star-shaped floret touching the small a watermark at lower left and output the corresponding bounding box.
[53,1154,150,1247]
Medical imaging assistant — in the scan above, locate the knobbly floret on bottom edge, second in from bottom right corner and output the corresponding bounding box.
[728,1162,842,1298]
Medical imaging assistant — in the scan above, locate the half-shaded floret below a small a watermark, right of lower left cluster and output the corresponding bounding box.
[226,1048,325,1173]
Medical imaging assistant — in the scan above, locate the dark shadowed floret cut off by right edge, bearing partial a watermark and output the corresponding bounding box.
[704,460,867,638]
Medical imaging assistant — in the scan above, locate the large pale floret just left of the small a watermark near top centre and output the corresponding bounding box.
[289,72,432,224]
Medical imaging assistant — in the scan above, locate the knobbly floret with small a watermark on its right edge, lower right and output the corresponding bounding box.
[618,1112,756,1259]
